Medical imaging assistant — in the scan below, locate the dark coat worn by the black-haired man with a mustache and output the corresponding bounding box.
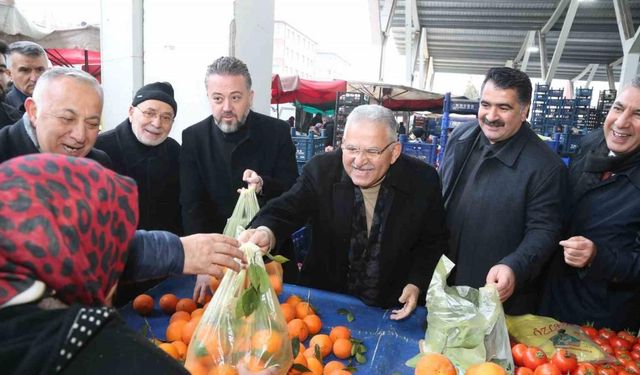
[440,122,567,314]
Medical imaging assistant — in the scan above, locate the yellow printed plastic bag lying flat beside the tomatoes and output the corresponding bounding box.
[507,314,610,362]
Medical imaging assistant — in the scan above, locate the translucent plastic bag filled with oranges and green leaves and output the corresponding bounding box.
[185,243,293,375]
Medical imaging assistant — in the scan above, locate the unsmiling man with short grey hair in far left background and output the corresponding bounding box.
[6,40,49,113]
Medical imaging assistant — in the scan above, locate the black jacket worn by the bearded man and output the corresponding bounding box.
[180,111,298,234]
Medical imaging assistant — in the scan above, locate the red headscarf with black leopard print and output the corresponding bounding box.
[0,154,138,306]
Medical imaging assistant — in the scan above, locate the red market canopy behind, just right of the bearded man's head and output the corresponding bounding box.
[271,74,347,113]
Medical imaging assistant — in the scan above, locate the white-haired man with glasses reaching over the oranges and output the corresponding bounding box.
[240,105,448,319]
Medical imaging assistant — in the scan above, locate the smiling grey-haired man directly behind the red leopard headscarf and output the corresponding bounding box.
[0,67,111,168]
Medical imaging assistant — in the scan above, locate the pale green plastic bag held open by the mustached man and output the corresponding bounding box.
[422,255,514,374]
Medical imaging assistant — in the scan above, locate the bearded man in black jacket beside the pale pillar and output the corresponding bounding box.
[180,57,298,302]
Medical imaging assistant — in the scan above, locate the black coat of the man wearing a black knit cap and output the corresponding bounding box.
[96,119,182,235]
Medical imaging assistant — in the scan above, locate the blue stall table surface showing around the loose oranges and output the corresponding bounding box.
[120,276,426,375]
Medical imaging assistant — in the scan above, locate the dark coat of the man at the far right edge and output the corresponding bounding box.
[540,130,640,331]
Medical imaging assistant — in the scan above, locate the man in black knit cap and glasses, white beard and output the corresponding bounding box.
[96,82,182,234]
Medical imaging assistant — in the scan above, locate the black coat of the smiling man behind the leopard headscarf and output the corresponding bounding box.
[0,119,111,168]
